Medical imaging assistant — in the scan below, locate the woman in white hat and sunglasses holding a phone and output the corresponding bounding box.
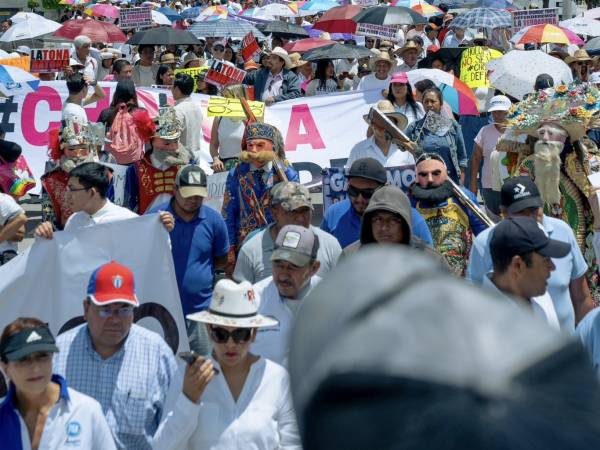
[153,280,301,450]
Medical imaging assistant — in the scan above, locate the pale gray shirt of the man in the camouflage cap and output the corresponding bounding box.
[233,224,342,283]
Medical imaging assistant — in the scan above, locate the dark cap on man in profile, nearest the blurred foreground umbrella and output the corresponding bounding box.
[490,217,571,258]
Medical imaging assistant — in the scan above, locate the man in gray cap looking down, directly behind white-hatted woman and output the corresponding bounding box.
[251,225,321,366]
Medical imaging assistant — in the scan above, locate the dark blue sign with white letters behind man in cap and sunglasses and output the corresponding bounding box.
[323,165,416,212]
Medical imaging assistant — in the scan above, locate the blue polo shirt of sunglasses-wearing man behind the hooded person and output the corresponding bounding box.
[321,199,433,248]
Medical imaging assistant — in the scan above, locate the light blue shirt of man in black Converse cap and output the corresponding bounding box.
[465,216,588,334]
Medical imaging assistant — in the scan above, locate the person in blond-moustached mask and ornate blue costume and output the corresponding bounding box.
[221,122,300,270]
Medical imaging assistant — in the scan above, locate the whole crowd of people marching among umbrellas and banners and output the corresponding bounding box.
[0,0,600,450]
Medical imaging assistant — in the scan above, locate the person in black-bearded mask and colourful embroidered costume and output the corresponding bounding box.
[411,153,487,276]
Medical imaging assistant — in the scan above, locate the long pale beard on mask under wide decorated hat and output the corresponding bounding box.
[533,141,564,204]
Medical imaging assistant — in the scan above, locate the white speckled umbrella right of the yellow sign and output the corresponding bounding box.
[487,50,573,99]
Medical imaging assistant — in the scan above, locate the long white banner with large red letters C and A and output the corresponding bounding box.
[0,81,381,192]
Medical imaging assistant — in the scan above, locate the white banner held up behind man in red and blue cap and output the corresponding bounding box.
[0,214,188,358]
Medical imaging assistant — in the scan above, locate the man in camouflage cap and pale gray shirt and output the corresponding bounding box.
[233,181,342,283]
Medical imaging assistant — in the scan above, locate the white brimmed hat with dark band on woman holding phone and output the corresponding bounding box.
[187,280,279,328]
